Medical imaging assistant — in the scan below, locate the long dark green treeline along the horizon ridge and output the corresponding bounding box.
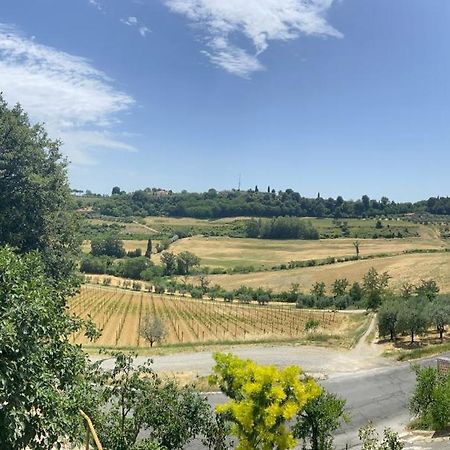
[77,187,450,219]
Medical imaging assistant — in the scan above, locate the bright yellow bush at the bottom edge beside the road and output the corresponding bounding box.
[211,353,320,450]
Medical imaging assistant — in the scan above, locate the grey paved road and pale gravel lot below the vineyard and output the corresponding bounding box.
[96,320,450,450]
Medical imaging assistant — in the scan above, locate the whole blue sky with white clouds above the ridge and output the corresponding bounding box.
[0,0,450,201]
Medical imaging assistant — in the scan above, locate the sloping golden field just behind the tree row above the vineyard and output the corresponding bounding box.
[200,252,450,293]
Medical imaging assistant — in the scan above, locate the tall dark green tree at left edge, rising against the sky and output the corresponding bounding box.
[0,95,80,281]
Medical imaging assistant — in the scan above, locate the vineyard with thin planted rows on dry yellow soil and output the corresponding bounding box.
[69,286,342,347]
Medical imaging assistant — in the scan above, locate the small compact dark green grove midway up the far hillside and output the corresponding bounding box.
[245,216,319,239]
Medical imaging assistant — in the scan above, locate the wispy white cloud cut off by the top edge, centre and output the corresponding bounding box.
[165,0,342,77]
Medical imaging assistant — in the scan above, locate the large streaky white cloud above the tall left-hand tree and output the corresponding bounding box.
[0,24,134,164]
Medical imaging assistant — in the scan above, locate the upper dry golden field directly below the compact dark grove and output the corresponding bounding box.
[170,236,448,268]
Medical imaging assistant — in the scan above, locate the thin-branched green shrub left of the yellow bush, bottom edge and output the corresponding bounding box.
[96,353,219,450]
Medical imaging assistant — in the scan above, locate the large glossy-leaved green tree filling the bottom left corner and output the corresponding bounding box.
[0,248,96,450]
